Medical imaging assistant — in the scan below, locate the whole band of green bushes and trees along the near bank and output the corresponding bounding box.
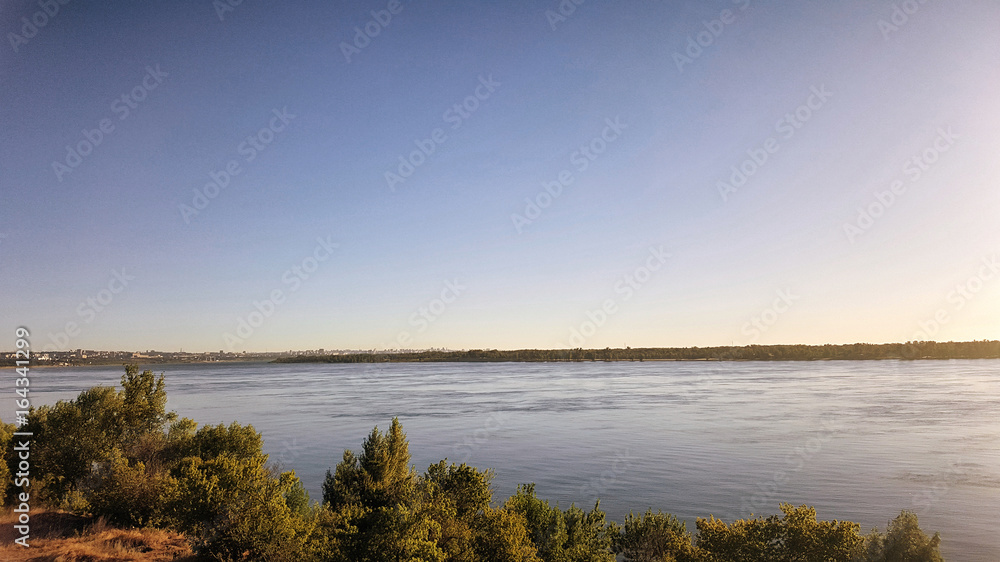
[0,365,942,562]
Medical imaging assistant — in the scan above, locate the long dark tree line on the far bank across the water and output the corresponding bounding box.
[274,340,1000,363]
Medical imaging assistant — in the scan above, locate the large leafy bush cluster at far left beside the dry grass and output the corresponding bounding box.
[6,365,314,560]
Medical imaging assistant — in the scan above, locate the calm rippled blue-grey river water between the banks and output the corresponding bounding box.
[0,360,1000,561]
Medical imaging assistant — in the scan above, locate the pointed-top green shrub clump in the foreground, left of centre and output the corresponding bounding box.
[309,419,538,562]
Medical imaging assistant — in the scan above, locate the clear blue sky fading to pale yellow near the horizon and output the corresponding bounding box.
[0,0,1000,351]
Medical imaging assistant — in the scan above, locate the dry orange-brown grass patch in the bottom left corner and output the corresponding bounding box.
[0,508,199,562]
